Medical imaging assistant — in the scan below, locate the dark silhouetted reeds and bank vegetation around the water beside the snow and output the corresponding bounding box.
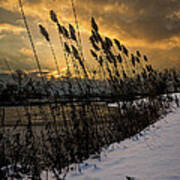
[0,0,180,180]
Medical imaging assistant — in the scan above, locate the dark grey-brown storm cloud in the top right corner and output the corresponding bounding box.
[124,0,180,41]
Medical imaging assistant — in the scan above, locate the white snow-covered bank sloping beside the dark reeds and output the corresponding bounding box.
[64,102,180,180]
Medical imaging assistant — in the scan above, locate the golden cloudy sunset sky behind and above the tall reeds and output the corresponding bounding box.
[0,0,180,73]
